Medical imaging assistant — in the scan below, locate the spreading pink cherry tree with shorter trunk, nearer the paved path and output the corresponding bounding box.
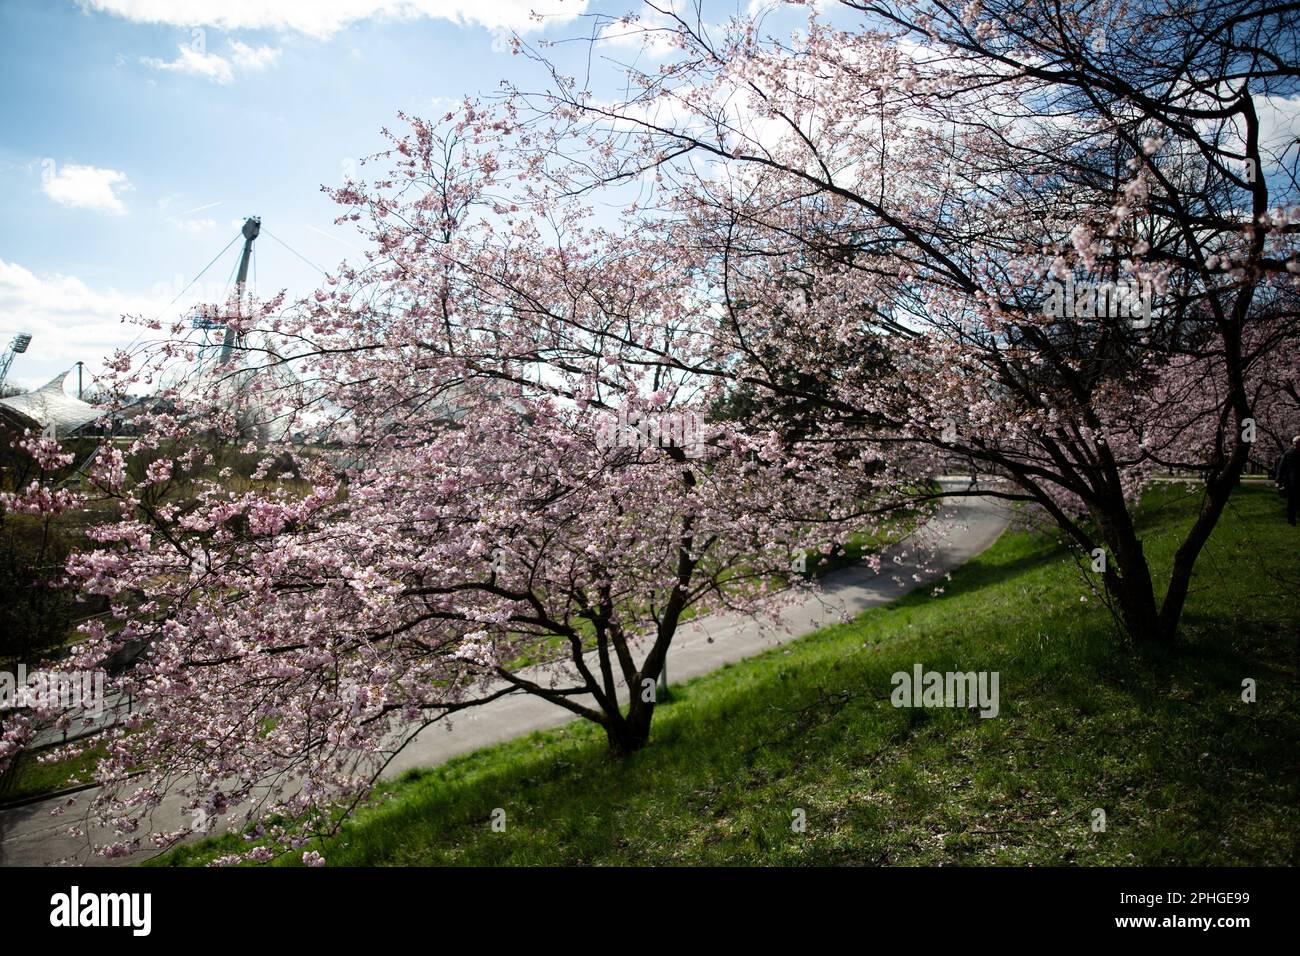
[45,119,904,860]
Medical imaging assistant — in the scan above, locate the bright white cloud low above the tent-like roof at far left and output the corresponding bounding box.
[0,259,166,388]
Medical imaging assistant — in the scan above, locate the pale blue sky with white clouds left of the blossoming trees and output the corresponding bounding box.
[0,0,738,392]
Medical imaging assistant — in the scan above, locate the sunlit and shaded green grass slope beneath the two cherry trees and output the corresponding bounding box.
[154,486,1300,865]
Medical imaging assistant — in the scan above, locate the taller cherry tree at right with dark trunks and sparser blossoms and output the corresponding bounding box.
[514,0,1300,641]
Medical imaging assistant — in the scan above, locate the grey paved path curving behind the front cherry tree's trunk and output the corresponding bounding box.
[0,480,1008,866]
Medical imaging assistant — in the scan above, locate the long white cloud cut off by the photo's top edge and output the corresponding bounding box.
[81,0,588,38]
